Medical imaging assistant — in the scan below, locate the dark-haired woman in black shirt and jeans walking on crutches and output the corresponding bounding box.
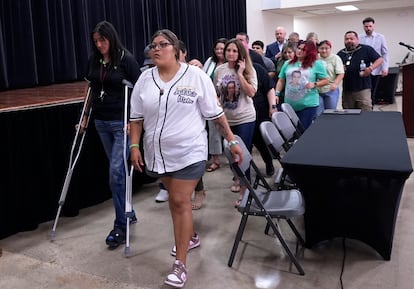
[81,21,140,248]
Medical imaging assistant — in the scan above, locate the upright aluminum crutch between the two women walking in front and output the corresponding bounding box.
[122,79,134,257]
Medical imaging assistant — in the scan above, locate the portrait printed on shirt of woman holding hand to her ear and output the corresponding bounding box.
[218,75,240,109]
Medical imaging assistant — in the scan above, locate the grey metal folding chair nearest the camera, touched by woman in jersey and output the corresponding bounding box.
[223,136,305,275]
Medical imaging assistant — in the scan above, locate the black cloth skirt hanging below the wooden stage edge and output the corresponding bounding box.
[0,103,153,239]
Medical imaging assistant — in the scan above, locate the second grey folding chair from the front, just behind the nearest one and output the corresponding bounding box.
[259,121,296,190]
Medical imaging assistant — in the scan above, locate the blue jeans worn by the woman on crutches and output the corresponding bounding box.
[95,119,129,229]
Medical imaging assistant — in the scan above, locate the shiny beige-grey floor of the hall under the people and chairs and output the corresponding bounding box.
[0,97,414,289]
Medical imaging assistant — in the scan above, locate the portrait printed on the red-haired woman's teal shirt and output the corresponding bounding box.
[285,67,309,101]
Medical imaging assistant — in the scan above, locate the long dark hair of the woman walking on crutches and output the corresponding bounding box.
[91,21,125,67]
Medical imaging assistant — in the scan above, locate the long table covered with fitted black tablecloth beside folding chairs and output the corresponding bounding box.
[282,112,412,260]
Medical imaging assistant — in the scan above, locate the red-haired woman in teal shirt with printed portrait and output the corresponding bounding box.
[276,41,329,129]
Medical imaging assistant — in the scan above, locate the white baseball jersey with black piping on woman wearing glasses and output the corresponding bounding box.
[130,63,223,174]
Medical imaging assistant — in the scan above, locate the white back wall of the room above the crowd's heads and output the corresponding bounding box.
[246,0,414,66]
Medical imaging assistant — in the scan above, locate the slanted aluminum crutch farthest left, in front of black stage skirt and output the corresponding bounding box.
[50,86,92,241]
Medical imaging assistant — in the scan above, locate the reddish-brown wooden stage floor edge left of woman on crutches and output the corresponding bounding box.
[0,81,87,113]
